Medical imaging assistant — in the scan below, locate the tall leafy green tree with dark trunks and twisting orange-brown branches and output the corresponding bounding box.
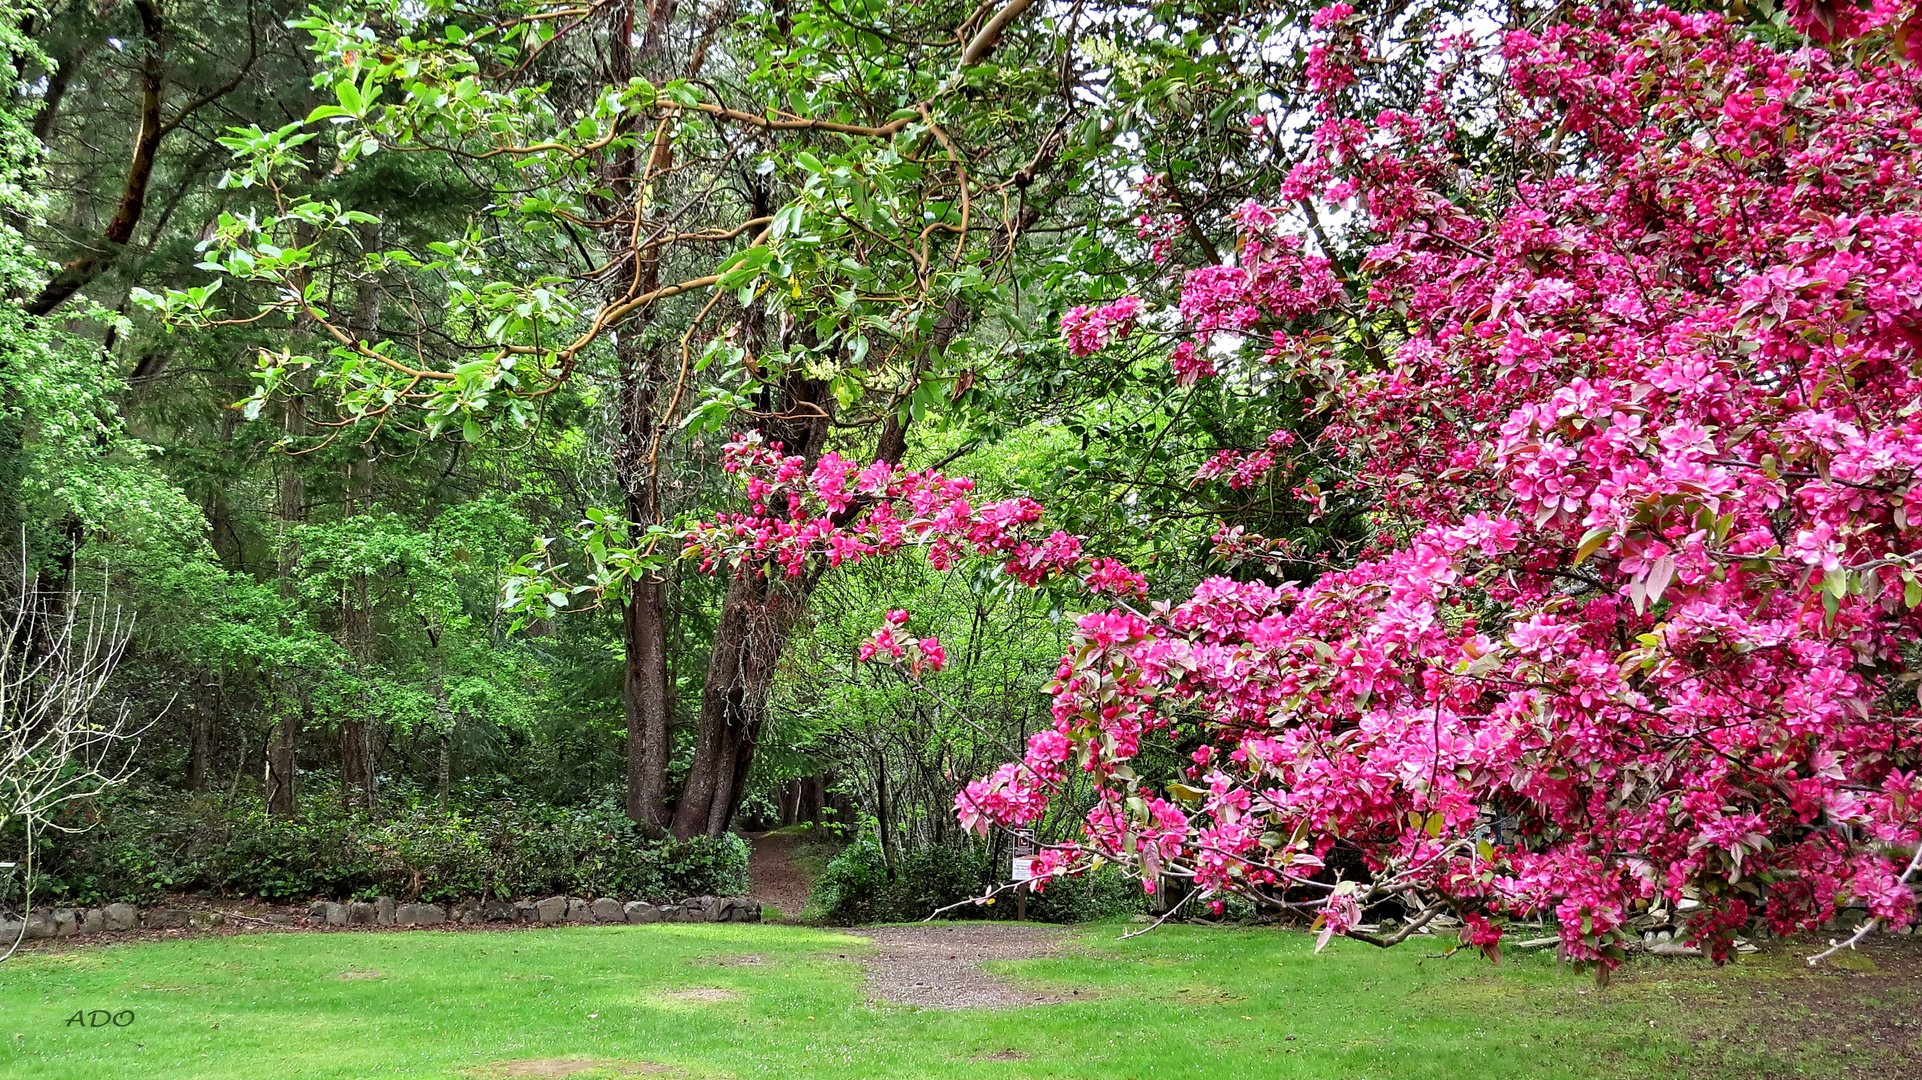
[154,2,1122,836]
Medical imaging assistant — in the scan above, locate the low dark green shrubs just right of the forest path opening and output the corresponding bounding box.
[809,836,1146,926]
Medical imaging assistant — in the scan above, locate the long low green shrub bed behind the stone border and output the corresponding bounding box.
[15,794,748,903]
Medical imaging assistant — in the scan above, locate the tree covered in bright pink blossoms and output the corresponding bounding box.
[694,2,1922,972]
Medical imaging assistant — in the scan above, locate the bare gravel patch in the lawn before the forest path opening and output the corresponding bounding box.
[855,922,1065,1009]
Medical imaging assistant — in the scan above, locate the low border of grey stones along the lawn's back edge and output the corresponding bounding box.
[0,896,761,945]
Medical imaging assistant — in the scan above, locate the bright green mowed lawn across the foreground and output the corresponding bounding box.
[0,924,1898,1080]
